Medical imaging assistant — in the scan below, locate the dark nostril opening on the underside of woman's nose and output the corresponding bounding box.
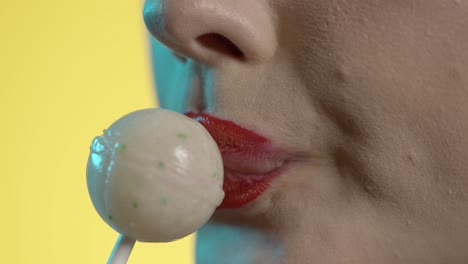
[197,33,245,60]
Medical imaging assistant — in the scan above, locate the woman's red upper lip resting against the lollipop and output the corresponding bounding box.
[186,112,288,174]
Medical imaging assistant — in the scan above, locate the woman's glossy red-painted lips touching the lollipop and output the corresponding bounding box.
[186,112,287,209]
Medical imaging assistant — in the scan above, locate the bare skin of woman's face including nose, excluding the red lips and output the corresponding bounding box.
[144,0,468,264]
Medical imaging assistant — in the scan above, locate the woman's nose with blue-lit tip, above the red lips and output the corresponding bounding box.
[143,0,277,65]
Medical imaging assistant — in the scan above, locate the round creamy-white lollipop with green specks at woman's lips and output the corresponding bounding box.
[87,109,224,263]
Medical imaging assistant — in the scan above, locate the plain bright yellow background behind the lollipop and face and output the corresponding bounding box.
[0,0,193,264]
